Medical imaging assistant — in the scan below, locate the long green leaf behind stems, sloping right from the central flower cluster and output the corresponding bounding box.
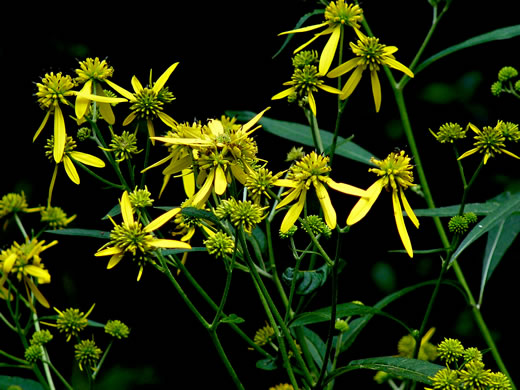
[226,111,374,166]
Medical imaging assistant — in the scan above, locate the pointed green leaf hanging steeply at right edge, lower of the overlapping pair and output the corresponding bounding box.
[479,215,520,305]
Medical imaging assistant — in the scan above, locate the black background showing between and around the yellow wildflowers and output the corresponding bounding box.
[0,0,518,389]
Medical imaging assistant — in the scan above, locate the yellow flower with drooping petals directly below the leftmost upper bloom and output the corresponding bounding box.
[45,137,105,205]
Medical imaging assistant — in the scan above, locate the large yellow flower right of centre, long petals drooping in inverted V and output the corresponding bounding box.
[347,151,419,257]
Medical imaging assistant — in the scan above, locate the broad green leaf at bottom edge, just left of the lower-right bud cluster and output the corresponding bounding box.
[326,356,445,385]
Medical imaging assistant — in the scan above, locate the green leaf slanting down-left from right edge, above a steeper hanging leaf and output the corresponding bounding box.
[450,193,520,264]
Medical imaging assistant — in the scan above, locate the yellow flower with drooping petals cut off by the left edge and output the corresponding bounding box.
[0,238,58,309]
